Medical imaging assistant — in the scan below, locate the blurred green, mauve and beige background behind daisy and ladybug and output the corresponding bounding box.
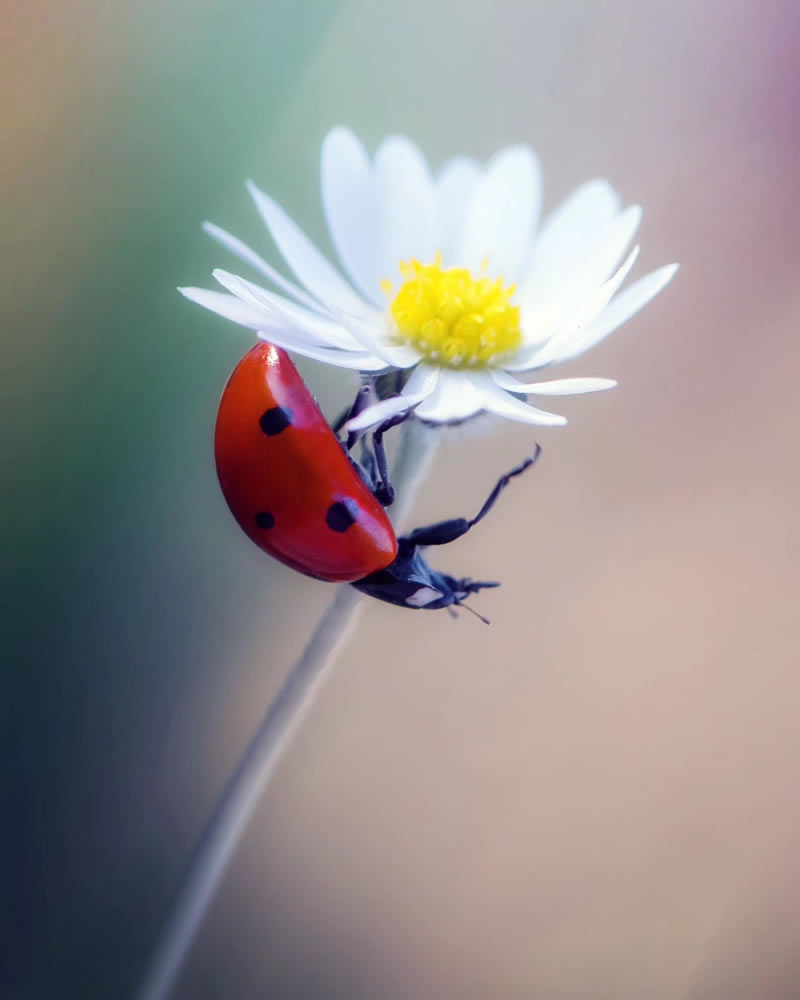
[0,0,800,1000]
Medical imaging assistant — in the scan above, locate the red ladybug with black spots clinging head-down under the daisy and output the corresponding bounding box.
[214,342,540,617]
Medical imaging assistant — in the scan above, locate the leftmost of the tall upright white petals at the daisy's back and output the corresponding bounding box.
[322,128,384,305]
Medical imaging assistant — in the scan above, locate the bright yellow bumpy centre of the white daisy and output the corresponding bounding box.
[381,253,522,368]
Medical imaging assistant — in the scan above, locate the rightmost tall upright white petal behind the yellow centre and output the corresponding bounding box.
[459,146,541,281]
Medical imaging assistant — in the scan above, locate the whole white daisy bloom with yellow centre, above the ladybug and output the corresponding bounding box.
[181,128,677,430]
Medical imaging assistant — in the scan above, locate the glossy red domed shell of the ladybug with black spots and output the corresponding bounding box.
[214,343,397,583]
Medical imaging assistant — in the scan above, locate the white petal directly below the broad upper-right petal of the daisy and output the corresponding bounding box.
[517,205,642,343]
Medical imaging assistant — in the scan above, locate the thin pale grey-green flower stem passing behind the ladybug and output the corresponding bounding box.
[136,420,436,1000]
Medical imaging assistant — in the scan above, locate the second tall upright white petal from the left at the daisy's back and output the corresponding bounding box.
[376,136,439,280]
